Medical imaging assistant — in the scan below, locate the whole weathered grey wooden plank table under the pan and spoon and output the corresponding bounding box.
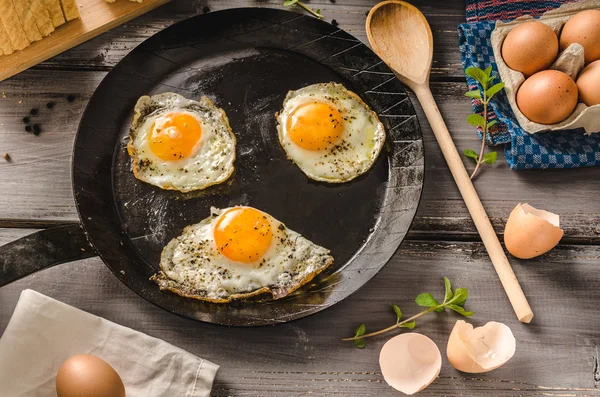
[0,0,600,397]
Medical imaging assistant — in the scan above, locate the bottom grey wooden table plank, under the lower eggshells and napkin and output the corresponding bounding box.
[0,229,600,397]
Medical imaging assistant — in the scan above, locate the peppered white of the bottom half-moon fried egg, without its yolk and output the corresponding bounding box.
[153,208,333,303]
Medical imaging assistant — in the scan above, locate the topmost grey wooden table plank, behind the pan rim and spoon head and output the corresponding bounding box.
[30,0,464,80]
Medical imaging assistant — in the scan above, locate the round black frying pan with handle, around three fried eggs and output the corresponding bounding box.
[0,8,423,326]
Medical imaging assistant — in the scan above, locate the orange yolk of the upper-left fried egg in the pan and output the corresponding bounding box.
[149,113,202,161]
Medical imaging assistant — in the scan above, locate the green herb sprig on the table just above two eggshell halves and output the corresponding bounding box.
[342,277,475,349]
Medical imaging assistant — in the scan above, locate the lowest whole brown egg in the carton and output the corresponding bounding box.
[517,70,578,124]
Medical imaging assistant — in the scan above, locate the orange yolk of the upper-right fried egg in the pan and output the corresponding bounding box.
[287,101,343,151]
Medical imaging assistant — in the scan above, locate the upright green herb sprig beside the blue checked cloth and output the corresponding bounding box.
[463,66,504,179]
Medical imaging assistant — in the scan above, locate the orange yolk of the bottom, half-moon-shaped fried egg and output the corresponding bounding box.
[214,207,273,263]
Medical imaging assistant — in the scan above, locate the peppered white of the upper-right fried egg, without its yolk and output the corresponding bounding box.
[276,83,385,183]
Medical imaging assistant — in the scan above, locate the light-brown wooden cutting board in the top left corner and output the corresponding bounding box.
[0,0,170,81]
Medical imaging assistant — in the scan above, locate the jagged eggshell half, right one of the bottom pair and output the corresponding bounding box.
[446,320,517,374]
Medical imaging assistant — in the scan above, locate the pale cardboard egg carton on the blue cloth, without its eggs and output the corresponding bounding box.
[491,0,600,134]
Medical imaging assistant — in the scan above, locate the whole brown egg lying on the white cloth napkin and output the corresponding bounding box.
[56,354,125,397]
